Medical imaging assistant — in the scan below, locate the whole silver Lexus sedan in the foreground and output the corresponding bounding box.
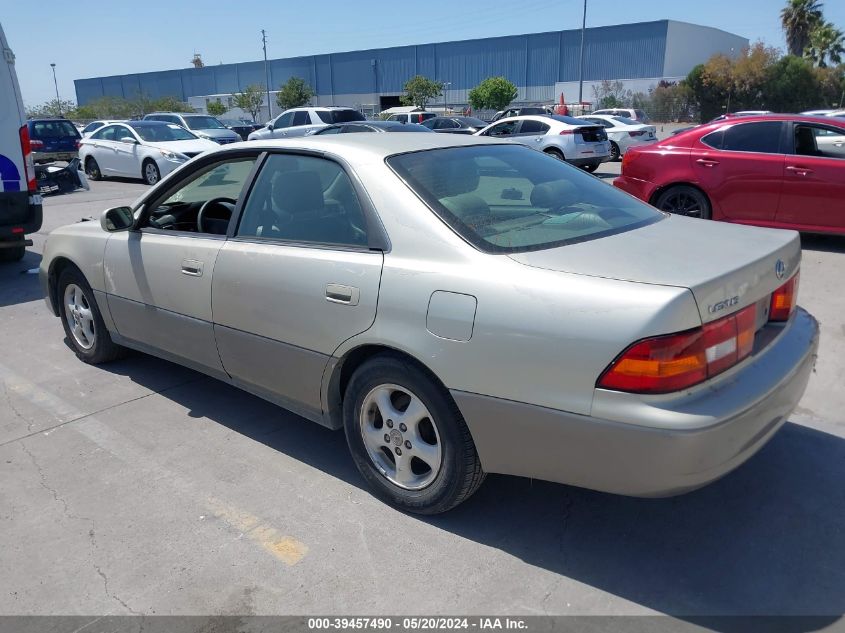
[40,134,818,514]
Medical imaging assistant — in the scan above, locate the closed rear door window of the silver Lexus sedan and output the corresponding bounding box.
[237,154,367,247]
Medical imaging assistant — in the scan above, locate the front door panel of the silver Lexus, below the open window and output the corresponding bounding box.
[104,230,223,374]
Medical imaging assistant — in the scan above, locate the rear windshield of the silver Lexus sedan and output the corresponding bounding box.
[387,145,665,253]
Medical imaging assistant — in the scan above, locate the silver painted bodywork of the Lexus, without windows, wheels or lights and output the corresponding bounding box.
[41,134,818,495]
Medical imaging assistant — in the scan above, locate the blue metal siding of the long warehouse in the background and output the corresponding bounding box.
[75,20,693,104]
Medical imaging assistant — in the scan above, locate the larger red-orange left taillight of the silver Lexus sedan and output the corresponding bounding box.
[597,304,757,393]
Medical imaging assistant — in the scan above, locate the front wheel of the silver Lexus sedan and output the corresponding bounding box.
[58,268,126,365]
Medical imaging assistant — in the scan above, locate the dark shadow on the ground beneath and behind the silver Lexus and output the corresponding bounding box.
[103,355,845,631]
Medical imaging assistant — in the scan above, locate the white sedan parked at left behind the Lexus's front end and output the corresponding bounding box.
[79,121,219,185]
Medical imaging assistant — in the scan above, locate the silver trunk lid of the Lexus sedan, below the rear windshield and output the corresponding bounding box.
[510,216,801,322]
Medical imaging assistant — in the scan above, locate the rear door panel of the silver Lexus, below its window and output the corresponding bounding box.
[212,240,383,417]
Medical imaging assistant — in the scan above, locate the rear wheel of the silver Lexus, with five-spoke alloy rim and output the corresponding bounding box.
[343,354,484,514]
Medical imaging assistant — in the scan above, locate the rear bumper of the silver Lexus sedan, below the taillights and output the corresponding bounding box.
[452,309,819,497]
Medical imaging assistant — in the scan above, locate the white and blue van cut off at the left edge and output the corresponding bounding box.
[0,25,41,262]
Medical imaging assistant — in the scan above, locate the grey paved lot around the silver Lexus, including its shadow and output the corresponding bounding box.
[0,164,845,622]
